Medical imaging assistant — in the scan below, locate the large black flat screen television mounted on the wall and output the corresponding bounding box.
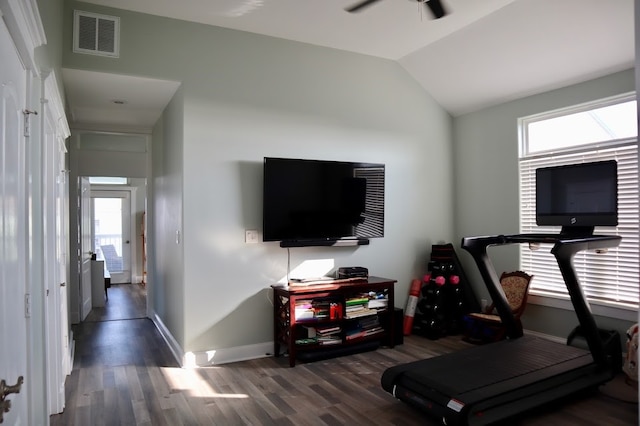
[263,157,385,247]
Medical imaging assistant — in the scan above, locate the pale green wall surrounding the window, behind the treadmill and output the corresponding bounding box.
[454,70,635,337]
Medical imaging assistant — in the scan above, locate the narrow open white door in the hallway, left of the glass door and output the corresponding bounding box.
[78,177,93,321]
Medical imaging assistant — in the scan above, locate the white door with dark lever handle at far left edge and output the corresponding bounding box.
[0,15,29,425]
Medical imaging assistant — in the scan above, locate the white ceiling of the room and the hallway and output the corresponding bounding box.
[63,0,634,127]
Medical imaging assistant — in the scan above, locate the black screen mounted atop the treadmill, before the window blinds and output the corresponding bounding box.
[536,160,618,235]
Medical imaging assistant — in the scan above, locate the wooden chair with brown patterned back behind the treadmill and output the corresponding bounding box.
[464,271,533,343]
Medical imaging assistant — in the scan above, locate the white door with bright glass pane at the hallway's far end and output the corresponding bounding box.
[91,190,131,284]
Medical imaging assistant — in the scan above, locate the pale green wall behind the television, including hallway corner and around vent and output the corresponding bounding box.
[63,1,453,351]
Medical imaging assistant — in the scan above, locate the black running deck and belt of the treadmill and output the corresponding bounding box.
[381,336,610,425]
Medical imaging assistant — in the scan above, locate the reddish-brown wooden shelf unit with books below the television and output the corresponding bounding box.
[271,277,396,367]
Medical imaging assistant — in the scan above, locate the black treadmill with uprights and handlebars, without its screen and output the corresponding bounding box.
[381,233,621,425]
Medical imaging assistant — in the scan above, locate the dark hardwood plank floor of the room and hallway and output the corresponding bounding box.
[51,286,638,426]
